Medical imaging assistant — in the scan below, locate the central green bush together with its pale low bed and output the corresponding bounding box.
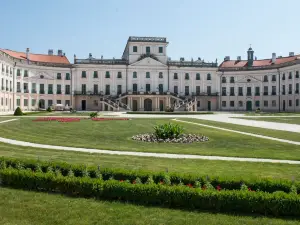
[132,123,209,143]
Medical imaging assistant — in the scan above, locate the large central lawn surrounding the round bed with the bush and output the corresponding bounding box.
[0,118,300,160]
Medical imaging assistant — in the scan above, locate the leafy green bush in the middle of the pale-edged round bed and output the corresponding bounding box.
[154,123,183,140]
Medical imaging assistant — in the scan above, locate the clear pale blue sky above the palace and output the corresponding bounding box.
[0,0,300,62]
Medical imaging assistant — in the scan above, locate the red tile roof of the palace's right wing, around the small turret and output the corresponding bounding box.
[219,55,300,68]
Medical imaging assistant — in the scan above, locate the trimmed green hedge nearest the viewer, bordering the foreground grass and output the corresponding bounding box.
[0,169,300,217]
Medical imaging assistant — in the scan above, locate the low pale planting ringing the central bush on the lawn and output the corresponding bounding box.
[132,134,209,143]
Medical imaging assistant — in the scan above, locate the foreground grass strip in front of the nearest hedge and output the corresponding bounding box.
[0,188,299,225]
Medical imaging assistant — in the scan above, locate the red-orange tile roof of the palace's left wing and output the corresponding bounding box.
[0,49,70,64]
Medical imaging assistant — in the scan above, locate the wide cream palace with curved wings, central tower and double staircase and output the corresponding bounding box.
[0,37,300,112]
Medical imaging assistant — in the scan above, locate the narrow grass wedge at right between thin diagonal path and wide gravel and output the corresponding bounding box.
[179,118,300,142]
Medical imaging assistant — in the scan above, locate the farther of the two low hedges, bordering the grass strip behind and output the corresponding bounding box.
[0,157,300,193]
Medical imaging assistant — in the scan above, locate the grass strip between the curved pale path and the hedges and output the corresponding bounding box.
[0,143,300,180]
